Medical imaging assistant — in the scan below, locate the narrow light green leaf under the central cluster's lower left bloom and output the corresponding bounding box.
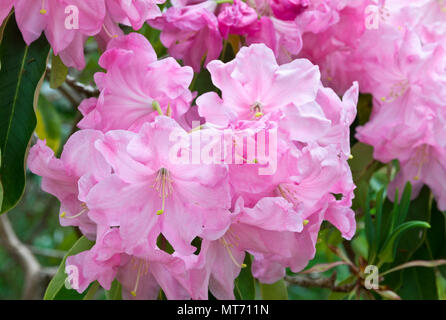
[43,236,94,300]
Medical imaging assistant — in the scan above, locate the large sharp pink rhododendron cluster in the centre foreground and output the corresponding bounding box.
[28,31,358,299]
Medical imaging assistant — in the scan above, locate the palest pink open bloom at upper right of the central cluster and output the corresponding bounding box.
[197,44,330,141]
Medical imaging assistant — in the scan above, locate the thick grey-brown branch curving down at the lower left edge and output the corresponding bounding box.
[0,214,43,300]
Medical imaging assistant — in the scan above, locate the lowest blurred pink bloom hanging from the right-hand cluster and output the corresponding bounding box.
[357,96,446,210]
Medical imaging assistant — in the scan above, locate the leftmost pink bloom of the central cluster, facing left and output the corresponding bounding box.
[28,130,111,237]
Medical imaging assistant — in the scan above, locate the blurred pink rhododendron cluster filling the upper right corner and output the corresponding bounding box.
[301,0,446,210]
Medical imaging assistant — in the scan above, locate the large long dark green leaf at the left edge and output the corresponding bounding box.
[0,17,50,213]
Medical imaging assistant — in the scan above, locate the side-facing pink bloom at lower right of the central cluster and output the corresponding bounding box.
[200,197,304,299]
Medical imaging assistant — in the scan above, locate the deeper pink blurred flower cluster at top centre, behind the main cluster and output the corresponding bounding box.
[149,0,366,72]
